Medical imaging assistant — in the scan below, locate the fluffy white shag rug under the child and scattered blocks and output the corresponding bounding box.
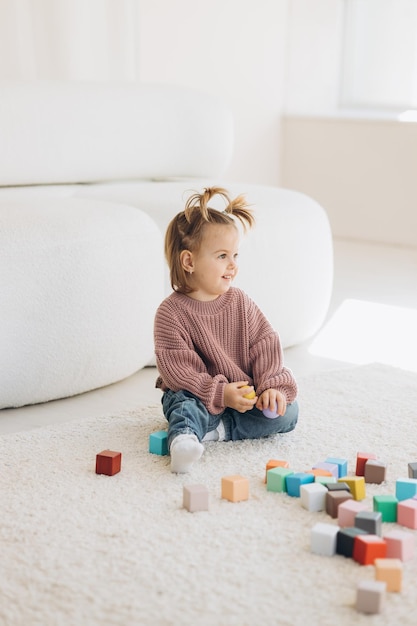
[0,365,417,626]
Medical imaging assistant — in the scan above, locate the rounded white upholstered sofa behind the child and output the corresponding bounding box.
[0,82,333,408]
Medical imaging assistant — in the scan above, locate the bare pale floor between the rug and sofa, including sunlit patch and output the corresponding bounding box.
[0,240,417,434]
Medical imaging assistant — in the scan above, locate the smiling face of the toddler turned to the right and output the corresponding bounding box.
[189,224,239,301]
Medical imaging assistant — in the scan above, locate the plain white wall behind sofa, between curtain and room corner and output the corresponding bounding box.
[139,0,288,185]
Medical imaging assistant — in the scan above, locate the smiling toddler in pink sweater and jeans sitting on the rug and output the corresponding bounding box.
[154,187,298,473]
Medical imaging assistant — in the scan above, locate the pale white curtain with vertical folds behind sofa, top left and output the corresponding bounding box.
[0,0,139,81]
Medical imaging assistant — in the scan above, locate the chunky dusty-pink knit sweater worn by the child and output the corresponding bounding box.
[154,287,297,415]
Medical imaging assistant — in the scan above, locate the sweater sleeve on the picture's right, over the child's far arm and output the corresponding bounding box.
[248,292,297,402]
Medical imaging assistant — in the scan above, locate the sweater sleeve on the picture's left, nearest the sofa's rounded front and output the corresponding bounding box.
[154,300,229,415]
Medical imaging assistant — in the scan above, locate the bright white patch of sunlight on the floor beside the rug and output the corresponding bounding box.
[309,300,417,372]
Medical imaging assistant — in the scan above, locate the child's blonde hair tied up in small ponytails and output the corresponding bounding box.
[165,187,255,294]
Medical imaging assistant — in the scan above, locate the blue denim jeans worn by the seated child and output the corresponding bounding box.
[161,390,298,446]
